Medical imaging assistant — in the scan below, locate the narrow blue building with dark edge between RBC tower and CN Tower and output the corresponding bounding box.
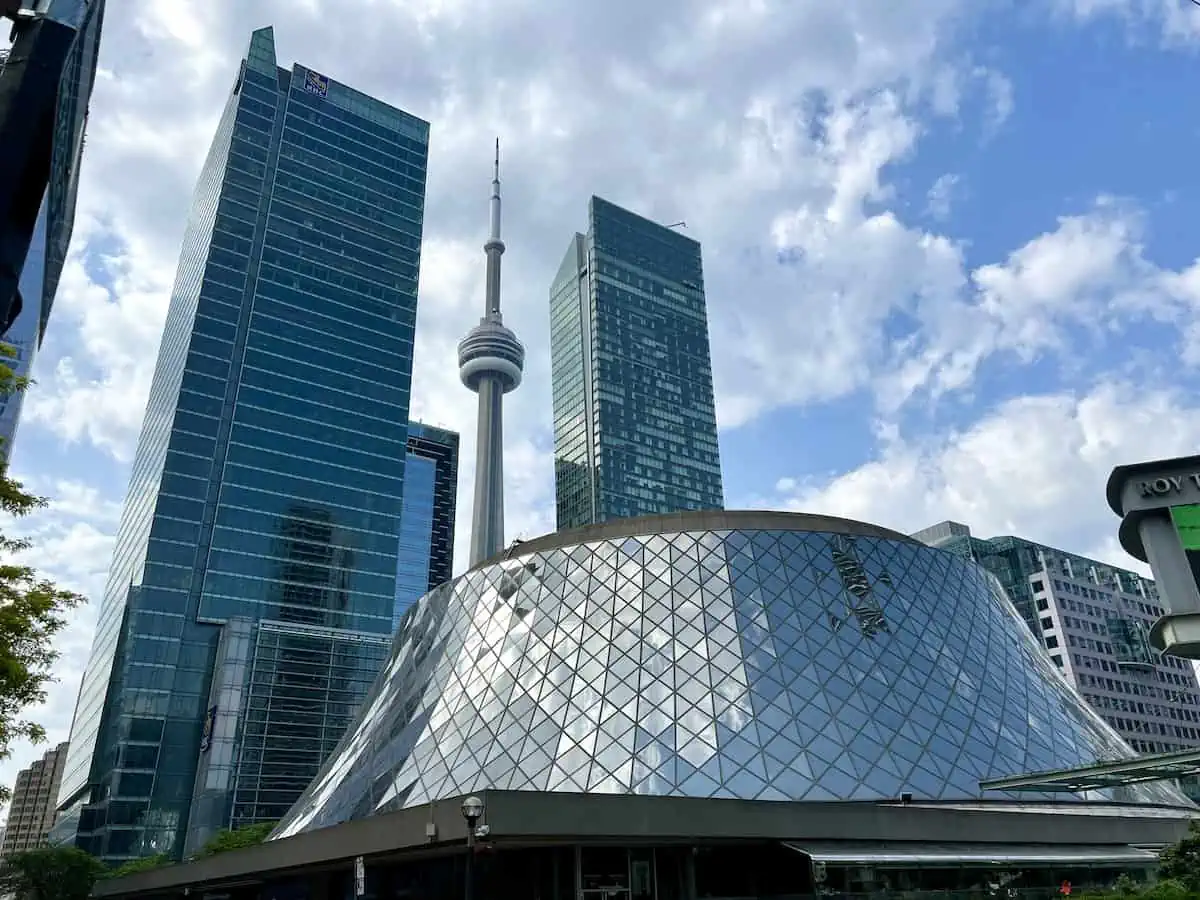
[394,421,458,624]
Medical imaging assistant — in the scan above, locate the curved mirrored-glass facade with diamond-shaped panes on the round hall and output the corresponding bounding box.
[274,511,1188,838]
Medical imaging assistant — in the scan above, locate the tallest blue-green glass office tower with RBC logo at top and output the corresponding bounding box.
[55,29,428,862]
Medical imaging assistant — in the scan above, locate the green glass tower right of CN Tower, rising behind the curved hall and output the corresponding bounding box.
[550,197,725,529]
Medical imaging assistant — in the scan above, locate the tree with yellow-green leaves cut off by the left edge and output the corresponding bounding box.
[0,344,84,802]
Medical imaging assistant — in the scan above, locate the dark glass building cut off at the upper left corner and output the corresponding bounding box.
[0,0,104,338]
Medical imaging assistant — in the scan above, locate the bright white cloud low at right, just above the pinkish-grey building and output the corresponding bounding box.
[762,382,1200,568]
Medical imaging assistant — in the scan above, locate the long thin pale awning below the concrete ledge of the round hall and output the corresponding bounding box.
[784,841,1158,866]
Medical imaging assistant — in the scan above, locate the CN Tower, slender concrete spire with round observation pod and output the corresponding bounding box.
[458,138,524,566]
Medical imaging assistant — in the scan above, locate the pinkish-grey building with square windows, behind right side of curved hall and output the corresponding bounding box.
[913,522,1200,754]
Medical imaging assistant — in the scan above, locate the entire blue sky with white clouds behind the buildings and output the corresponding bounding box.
[0,0,1200,806]
